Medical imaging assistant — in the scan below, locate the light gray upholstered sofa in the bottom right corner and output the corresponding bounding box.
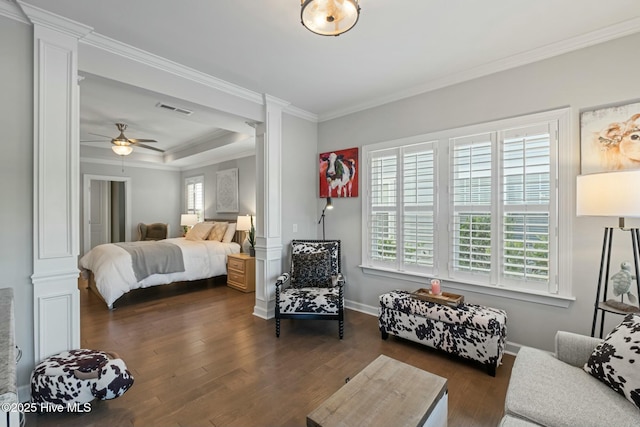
[500,331,640,427]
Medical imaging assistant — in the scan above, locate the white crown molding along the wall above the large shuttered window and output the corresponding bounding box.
[318,18,640,122]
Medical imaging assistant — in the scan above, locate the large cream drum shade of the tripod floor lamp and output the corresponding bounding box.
[576,170,640,218]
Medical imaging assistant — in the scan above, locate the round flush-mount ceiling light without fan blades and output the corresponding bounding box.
[300,0,360,36]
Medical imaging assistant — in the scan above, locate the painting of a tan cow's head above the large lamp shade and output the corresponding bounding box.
[580,102,640,175]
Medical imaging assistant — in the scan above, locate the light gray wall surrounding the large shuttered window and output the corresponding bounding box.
[314,31,640,350]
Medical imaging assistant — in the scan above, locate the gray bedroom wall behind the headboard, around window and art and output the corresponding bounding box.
[179,156,256,219]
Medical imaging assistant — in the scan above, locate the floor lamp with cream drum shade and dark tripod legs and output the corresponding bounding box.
[576,170,640,338]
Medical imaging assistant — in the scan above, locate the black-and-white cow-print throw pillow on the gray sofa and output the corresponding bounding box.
[584,313,640,409]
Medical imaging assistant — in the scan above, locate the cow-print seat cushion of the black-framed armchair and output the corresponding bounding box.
[279,287,340,314]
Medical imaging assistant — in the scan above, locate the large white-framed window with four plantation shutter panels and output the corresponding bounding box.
[362,109,571,295]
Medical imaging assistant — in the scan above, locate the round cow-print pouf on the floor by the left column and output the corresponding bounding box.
[31,349,133,405]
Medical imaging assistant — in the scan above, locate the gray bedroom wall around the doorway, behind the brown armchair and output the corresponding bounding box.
[80,160,182,242]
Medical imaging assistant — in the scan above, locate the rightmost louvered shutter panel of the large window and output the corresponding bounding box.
[501,123,556,291]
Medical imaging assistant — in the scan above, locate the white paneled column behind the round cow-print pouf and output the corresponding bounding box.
[19,2,91,363]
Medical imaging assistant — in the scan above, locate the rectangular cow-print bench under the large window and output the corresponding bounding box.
[378,290,507,376]
